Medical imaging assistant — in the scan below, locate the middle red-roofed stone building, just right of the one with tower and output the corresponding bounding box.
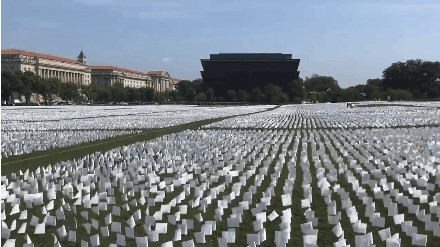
[89,66,154,88]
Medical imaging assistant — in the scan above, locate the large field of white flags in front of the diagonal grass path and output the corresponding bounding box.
[1,101,440,247]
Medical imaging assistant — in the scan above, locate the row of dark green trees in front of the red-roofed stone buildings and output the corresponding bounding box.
[1,71,179,104]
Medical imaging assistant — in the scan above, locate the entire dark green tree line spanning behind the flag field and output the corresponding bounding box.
[1,59,440,104]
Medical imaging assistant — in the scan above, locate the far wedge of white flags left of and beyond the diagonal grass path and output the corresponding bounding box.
[1,105,271,157]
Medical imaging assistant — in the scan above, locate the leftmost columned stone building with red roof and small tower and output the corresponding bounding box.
[2,49,91,85]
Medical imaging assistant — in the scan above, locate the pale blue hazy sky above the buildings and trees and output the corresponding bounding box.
[1,0,440,88]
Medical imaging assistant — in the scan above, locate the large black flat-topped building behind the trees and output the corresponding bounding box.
[201,53,300,97]
